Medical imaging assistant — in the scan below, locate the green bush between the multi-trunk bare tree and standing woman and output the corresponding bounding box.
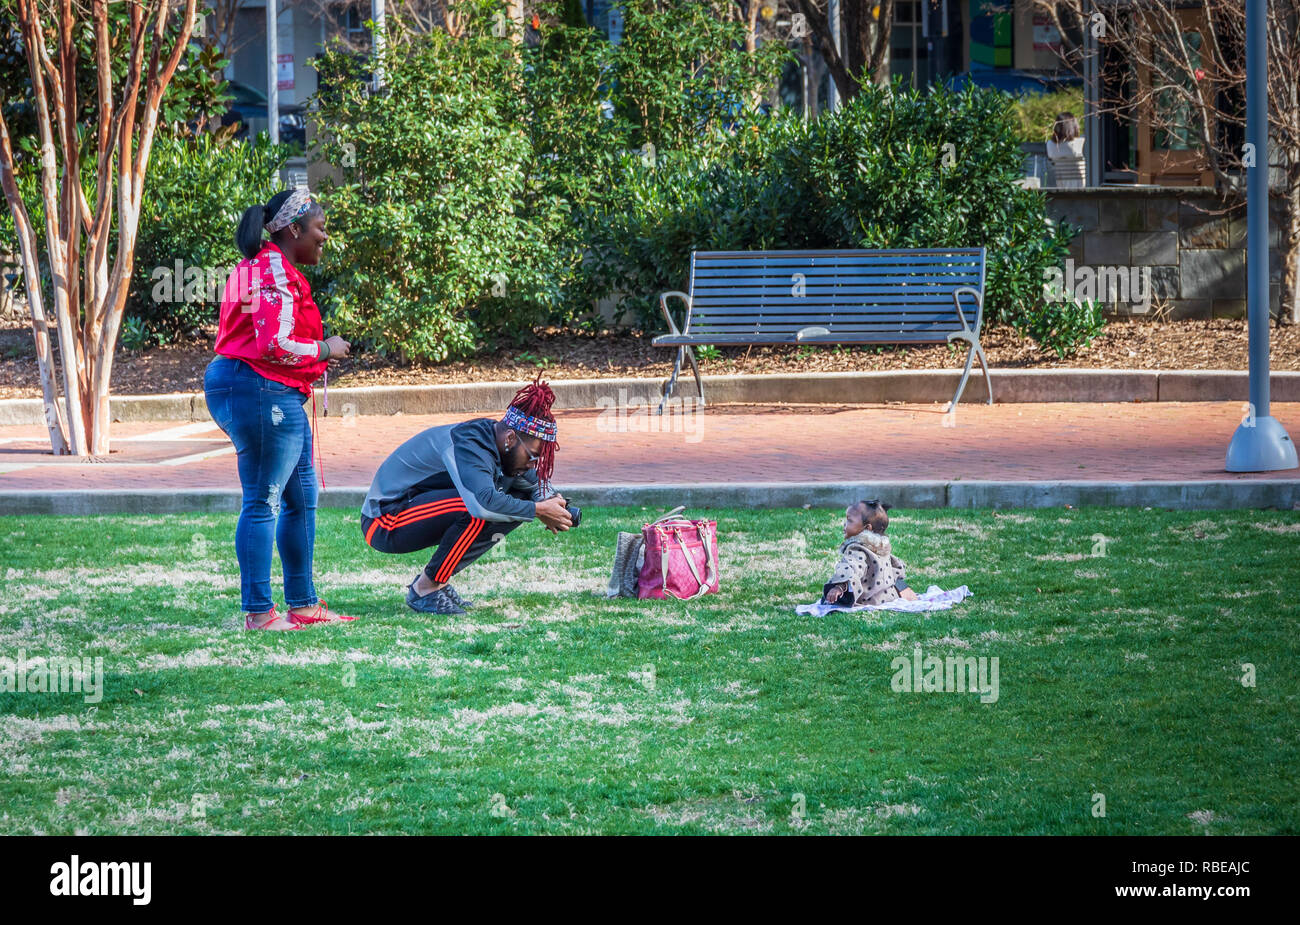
[124,133,287,340]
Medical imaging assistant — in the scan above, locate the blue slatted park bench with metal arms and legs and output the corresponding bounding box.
[651,247,993,413]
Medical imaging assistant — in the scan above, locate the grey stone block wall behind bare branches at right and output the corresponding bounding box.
[1044,187,1282,320]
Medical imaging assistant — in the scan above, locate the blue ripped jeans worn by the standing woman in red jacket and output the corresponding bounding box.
[203,356,317,613]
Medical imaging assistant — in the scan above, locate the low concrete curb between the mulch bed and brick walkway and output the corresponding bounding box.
[0,369,1300,425]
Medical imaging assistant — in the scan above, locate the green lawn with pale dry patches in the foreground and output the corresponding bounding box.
[0,499,1300,834]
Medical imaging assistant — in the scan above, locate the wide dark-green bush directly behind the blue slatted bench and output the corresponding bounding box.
[584,83,1073,326]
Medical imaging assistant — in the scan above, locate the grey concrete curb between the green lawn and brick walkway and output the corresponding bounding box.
[0,479,1300,516]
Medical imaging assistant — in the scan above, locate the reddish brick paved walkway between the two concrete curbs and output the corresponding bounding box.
[0,403,1300,491]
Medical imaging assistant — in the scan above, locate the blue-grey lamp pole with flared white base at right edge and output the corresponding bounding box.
[1225,0,1297,472]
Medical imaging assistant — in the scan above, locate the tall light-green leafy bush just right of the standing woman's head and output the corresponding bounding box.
[320,20,558,360]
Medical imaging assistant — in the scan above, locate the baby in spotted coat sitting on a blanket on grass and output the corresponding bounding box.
[822,499,917,607]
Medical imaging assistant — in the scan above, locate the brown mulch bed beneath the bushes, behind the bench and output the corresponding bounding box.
[0,318,1300,399]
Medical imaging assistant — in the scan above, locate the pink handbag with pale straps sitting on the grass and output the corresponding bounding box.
[637,508,718,600]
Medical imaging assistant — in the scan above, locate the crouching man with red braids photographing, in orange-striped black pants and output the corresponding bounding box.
[361,379,573,615]
